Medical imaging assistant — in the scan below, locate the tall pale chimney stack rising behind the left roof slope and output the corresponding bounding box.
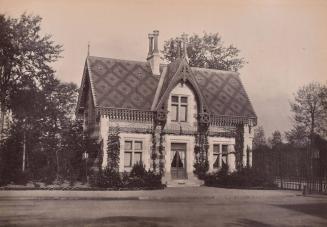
[147,30,160,75]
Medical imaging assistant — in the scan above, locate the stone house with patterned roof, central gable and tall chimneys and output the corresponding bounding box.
[77,31,257,184]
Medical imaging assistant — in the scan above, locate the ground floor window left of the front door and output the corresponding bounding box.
[124,140,143,167]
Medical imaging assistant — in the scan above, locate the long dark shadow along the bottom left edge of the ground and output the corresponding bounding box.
[0,215,176,227]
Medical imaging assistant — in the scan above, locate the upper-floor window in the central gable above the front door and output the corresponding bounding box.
[171,95,188,122]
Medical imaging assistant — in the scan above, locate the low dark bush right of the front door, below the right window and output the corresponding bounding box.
[204,168,276,188]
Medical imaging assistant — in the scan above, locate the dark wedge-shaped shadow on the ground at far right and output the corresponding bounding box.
[276,203,327,219]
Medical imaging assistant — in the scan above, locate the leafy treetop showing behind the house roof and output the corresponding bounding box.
[162,32,246,71]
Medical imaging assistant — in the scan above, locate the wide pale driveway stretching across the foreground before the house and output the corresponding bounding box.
[0,187,327,227]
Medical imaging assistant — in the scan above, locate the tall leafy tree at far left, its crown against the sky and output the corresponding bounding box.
[0,14,62,141]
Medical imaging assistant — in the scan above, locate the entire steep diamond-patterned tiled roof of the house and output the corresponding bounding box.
[78,56,256,118]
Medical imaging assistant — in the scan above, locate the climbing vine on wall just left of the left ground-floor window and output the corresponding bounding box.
[107,126,120,172]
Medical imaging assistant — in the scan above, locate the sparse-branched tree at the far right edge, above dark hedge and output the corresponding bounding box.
[289,82,327,145]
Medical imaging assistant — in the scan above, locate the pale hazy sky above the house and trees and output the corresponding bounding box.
[0,0,327,137]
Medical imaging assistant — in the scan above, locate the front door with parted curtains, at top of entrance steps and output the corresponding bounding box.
[170,143,187,179]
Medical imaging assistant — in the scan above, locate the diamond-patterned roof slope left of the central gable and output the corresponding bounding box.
[87,56,159,110]
